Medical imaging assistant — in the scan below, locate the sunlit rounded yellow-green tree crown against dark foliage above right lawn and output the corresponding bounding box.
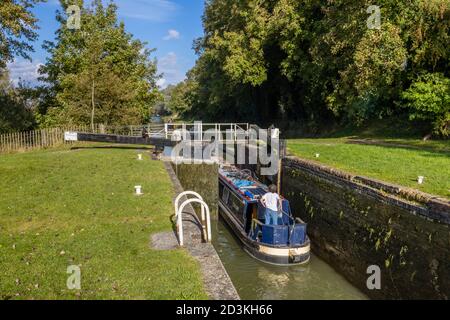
[327,23,407,123]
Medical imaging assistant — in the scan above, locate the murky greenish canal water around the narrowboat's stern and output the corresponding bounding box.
[213,219,367,300]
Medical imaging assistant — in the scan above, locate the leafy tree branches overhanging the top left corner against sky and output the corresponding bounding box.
[0,0,45,68]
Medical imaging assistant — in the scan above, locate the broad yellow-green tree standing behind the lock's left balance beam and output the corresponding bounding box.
[40,0,158,125]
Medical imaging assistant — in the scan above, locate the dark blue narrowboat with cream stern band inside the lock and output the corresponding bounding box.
[219,165,310,266]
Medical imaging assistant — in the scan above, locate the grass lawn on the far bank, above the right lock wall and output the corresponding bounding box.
[288,138,450,198]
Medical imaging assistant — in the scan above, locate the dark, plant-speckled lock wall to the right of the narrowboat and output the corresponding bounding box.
[282,157,450,299]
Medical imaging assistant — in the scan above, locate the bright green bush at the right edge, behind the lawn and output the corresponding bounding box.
[402,73,450,137]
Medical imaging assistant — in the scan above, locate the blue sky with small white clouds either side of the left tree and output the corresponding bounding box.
[9,0,204,87]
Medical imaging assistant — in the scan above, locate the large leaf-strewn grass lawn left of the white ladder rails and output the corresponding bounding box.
[0,148,207,299]
